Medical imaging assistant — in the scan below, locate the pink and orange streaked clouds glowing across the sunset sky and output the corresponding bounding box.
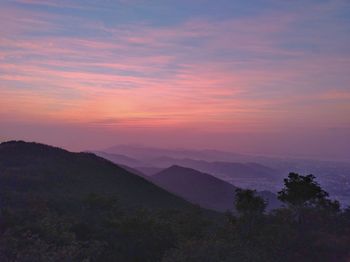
[0,0,350,138]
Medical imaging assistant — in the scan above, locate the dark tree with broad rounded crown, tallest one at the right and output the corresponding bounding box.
[278,173,339,224]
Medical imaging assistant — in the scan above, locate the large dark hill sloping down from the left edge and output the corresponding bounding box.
[0,141,190,211]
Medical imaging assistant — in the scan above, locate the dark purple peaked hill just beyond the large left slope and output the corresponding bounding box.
[151,165,280,211]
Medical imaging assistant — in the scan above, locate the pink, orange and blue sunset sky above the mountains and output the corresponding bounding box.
[0,0,350,161]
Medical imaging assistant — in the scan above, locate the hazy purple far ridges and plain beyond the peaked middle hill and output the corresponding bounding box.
[97,145,350,206]
